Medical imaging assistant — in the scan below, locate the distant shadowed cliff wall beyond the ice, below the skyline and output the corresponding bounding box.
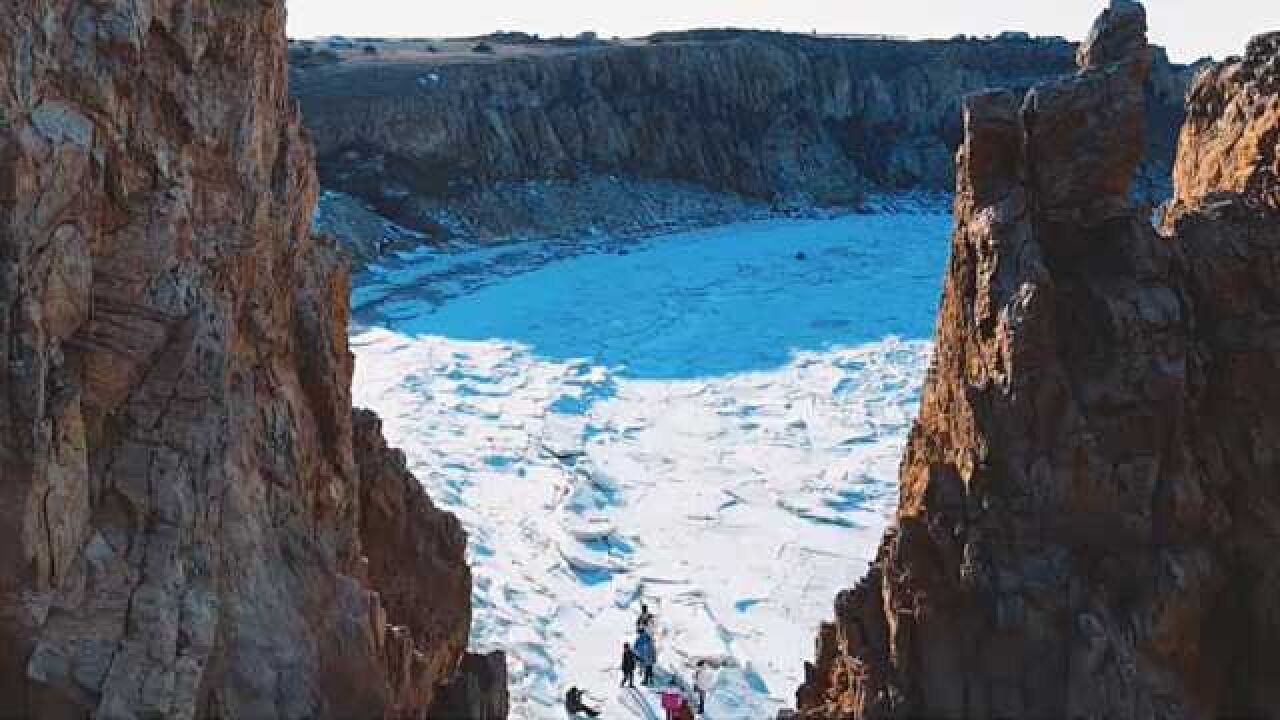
[292,32,1188,244]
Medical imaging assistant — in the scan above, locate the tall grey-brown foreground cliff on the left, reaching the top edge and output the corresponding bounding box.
[0,0,481,719]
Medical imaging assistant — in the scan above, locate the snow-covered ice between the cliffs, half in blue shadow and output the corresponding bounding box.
[352,214,950,720]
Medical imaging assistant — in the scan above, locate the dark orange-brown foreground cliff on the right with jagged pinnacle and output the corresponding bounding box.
[797,0,1280,719]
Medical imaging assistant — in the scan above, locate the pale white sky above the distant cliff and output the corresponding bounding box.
[287,0,1280,61]
